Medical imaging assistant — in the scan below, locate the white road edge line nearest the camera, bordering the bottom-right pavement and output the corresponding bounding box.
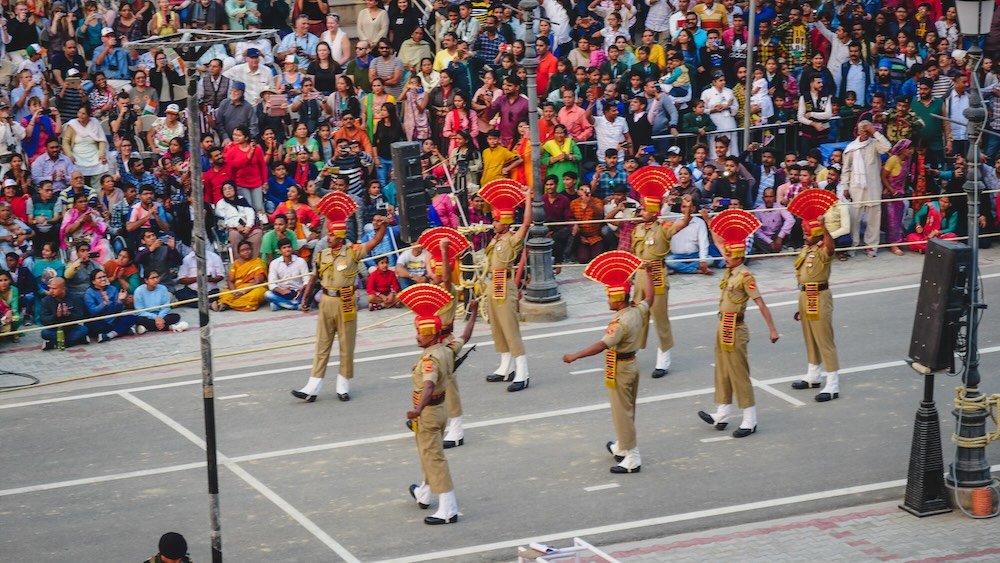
[382,465,1000,563]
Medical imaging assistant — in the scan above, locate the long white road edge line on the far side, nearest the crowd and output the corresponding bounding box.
[7,273,988,410]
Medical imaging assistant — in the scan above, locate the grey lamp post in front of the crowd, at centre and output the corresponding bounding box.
[518,0,566,321]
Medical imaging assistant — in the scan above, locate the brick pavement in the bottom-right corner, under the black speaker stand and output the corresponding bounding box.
[592,501,1000,563]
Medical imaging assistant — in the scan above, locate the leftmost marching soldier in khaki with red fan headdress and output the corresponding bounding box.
[292,192,386,403]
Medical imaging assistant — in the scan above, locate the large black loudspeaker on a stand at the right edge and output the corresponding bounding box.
[910,239,972,371]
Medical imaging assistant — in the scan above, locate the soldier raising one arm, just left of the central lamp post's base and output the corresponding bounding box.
[477,178,531,392]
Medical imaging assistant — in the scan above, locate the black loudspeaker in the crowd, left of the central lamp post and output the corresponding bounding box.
[391,141,430,244]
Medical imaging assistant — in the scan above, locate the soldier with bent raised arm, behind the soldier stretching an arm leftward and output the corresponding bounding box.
[629,166,691,379]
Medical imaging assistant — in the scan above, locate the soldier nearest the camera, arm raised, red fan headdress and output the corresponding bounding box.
[399,283,476,525]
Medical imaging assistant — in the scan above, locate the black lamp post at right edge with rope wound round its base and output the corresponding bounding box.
[947,0,994,502]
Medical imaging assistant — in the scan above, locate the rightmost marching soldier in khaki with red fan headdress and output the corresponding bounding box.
[788,190,840,403]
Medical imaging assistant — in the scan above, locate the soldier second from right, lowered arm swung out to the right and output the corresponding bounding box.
[698,209,778,438]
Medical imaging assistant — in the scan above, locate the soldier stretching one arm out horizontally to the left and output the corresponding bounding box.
[563,250,656,473]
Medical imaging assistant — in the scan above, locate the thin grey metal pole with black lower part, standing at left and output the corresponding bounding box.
[188,72,222,563]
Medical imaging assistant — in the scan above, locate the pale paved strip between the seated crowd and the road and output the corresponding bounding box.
[0,248,1000,392]
